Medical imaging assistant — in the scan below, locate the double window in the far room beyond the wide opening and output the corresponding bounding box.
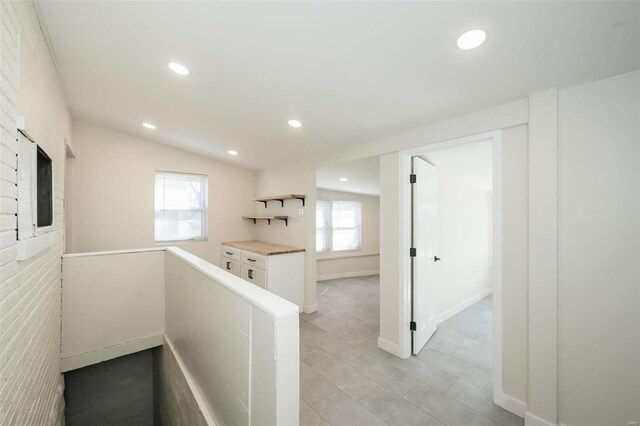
[316,201,362,251]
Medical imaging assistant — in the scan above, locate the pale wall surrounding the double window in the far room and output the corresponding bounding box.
[316,188,380,280]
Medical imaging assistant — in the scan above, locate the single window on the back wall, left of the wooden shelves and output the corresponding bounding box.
[155,172,208,242]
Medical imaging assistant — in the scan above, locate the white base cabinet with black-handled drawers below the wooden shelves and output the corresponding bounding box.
[220,241,304,312]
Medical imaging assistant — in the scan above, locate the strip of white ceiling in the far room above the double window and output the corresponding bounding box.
[316,157,380,195]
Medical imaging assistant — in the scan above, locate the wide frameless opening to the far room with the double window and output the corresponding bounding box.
[315,157,380,340]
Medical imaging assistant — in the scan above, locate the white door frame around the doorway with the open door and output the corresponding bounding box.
[399,130,504,407]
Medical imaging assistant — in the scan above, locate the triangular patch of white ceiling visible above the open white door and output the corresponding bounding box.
[421,140,493,191]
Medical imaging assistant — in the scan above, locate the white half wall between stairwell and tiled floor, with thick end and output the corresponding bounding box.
[165,249,300,426]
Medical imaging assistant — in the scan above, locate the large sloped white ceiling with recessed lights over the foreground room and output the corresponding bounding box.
[39,1,640,169]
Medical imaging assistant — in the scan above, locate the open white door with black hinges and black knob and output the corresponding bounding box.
[411,157,439,355]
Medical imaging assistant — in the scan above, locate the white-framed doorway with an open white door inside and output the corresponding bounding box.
[401,131,502,405]
